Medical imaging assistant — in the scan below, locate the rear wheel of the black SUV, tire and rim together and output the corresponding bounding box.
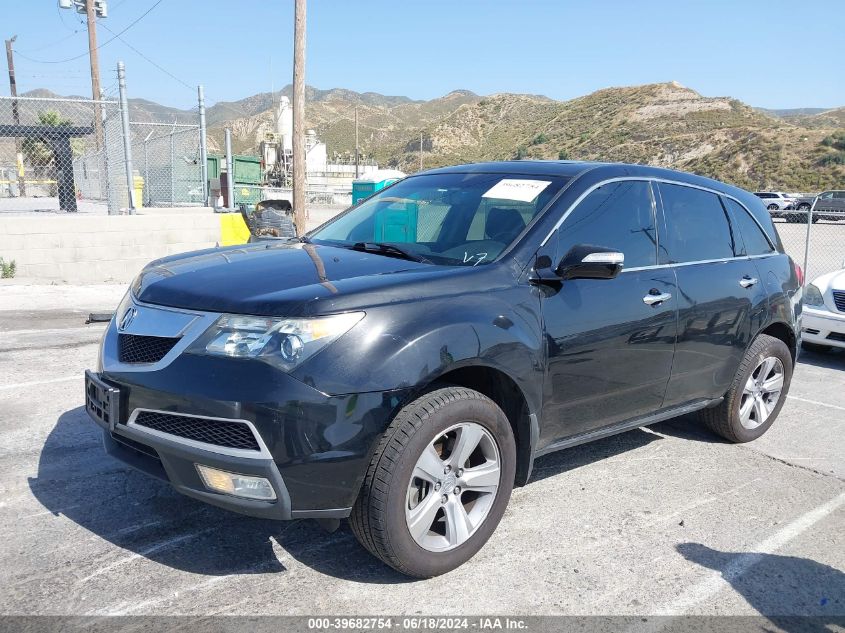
[700,334,792,443]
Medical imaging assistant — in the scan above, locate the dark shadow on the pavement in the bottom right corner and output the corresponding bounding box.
[676,543,845,633]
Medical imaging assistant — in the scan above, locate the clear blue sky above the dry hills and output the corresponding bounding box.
[6,0,845,108]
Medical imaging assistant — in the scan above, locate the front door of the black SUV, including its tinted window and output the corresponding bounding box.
[540,180,676,448]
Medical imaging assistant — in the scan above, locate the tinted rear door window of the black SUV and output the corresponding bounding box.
[659,183,741,264]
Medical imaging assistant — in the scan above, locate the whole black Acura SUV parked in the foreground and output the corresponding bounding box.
[86,161,801,577]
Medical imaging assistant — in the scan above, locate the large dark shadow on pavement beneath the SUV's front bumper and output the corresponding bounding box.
[29,407,408,583]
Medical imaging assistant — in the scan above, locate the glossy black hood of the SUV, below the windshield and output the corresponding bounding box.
[132,243,488,316]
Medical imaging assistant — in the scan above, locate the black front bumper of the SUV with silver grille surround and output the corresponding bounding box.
[86,302,410,519]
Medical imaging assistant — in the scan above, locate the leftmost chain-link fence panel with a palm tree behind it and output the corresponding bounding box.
[0,97,128,211]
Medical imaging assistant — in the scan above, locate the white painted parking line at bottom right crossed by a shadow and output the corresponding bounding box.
[656,493,845,616]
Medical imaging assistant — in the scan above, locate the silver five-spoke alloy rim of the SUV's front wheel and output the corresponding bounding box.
[405,422,501,552]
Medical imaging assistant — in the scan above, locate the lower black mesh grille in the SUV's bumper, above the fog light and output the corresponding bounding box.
[135,411,261,451]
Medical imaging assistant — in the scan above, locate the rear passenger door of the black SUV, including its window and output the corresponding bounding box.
[658,182,766,407]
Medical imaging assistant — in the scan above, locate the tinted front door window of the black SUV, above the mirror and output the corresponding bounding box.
[558,180,657,268]
